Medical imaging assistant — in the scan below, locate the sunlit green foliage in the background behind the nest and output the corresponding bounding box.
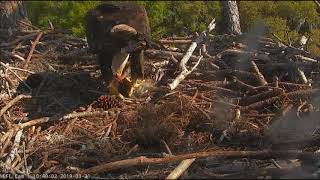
[26,1,320,55]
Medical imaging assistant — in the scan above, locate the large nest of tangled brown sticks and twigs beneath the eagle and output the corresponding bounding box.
[0,24,320,178]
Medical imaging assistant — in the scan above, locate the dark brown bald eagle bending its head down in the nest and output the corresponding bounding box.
[86,2,150,96]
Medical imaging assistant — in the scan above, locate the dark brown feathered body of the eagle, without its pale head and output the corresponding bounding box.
[86,2,150,91]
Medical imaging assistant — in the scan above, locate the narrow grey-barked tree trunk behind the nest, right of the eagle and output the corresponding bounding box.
[221,1,242,35]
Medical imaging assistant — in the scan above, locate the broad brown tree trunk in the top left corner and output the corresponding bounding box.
[0,1,31,31]
